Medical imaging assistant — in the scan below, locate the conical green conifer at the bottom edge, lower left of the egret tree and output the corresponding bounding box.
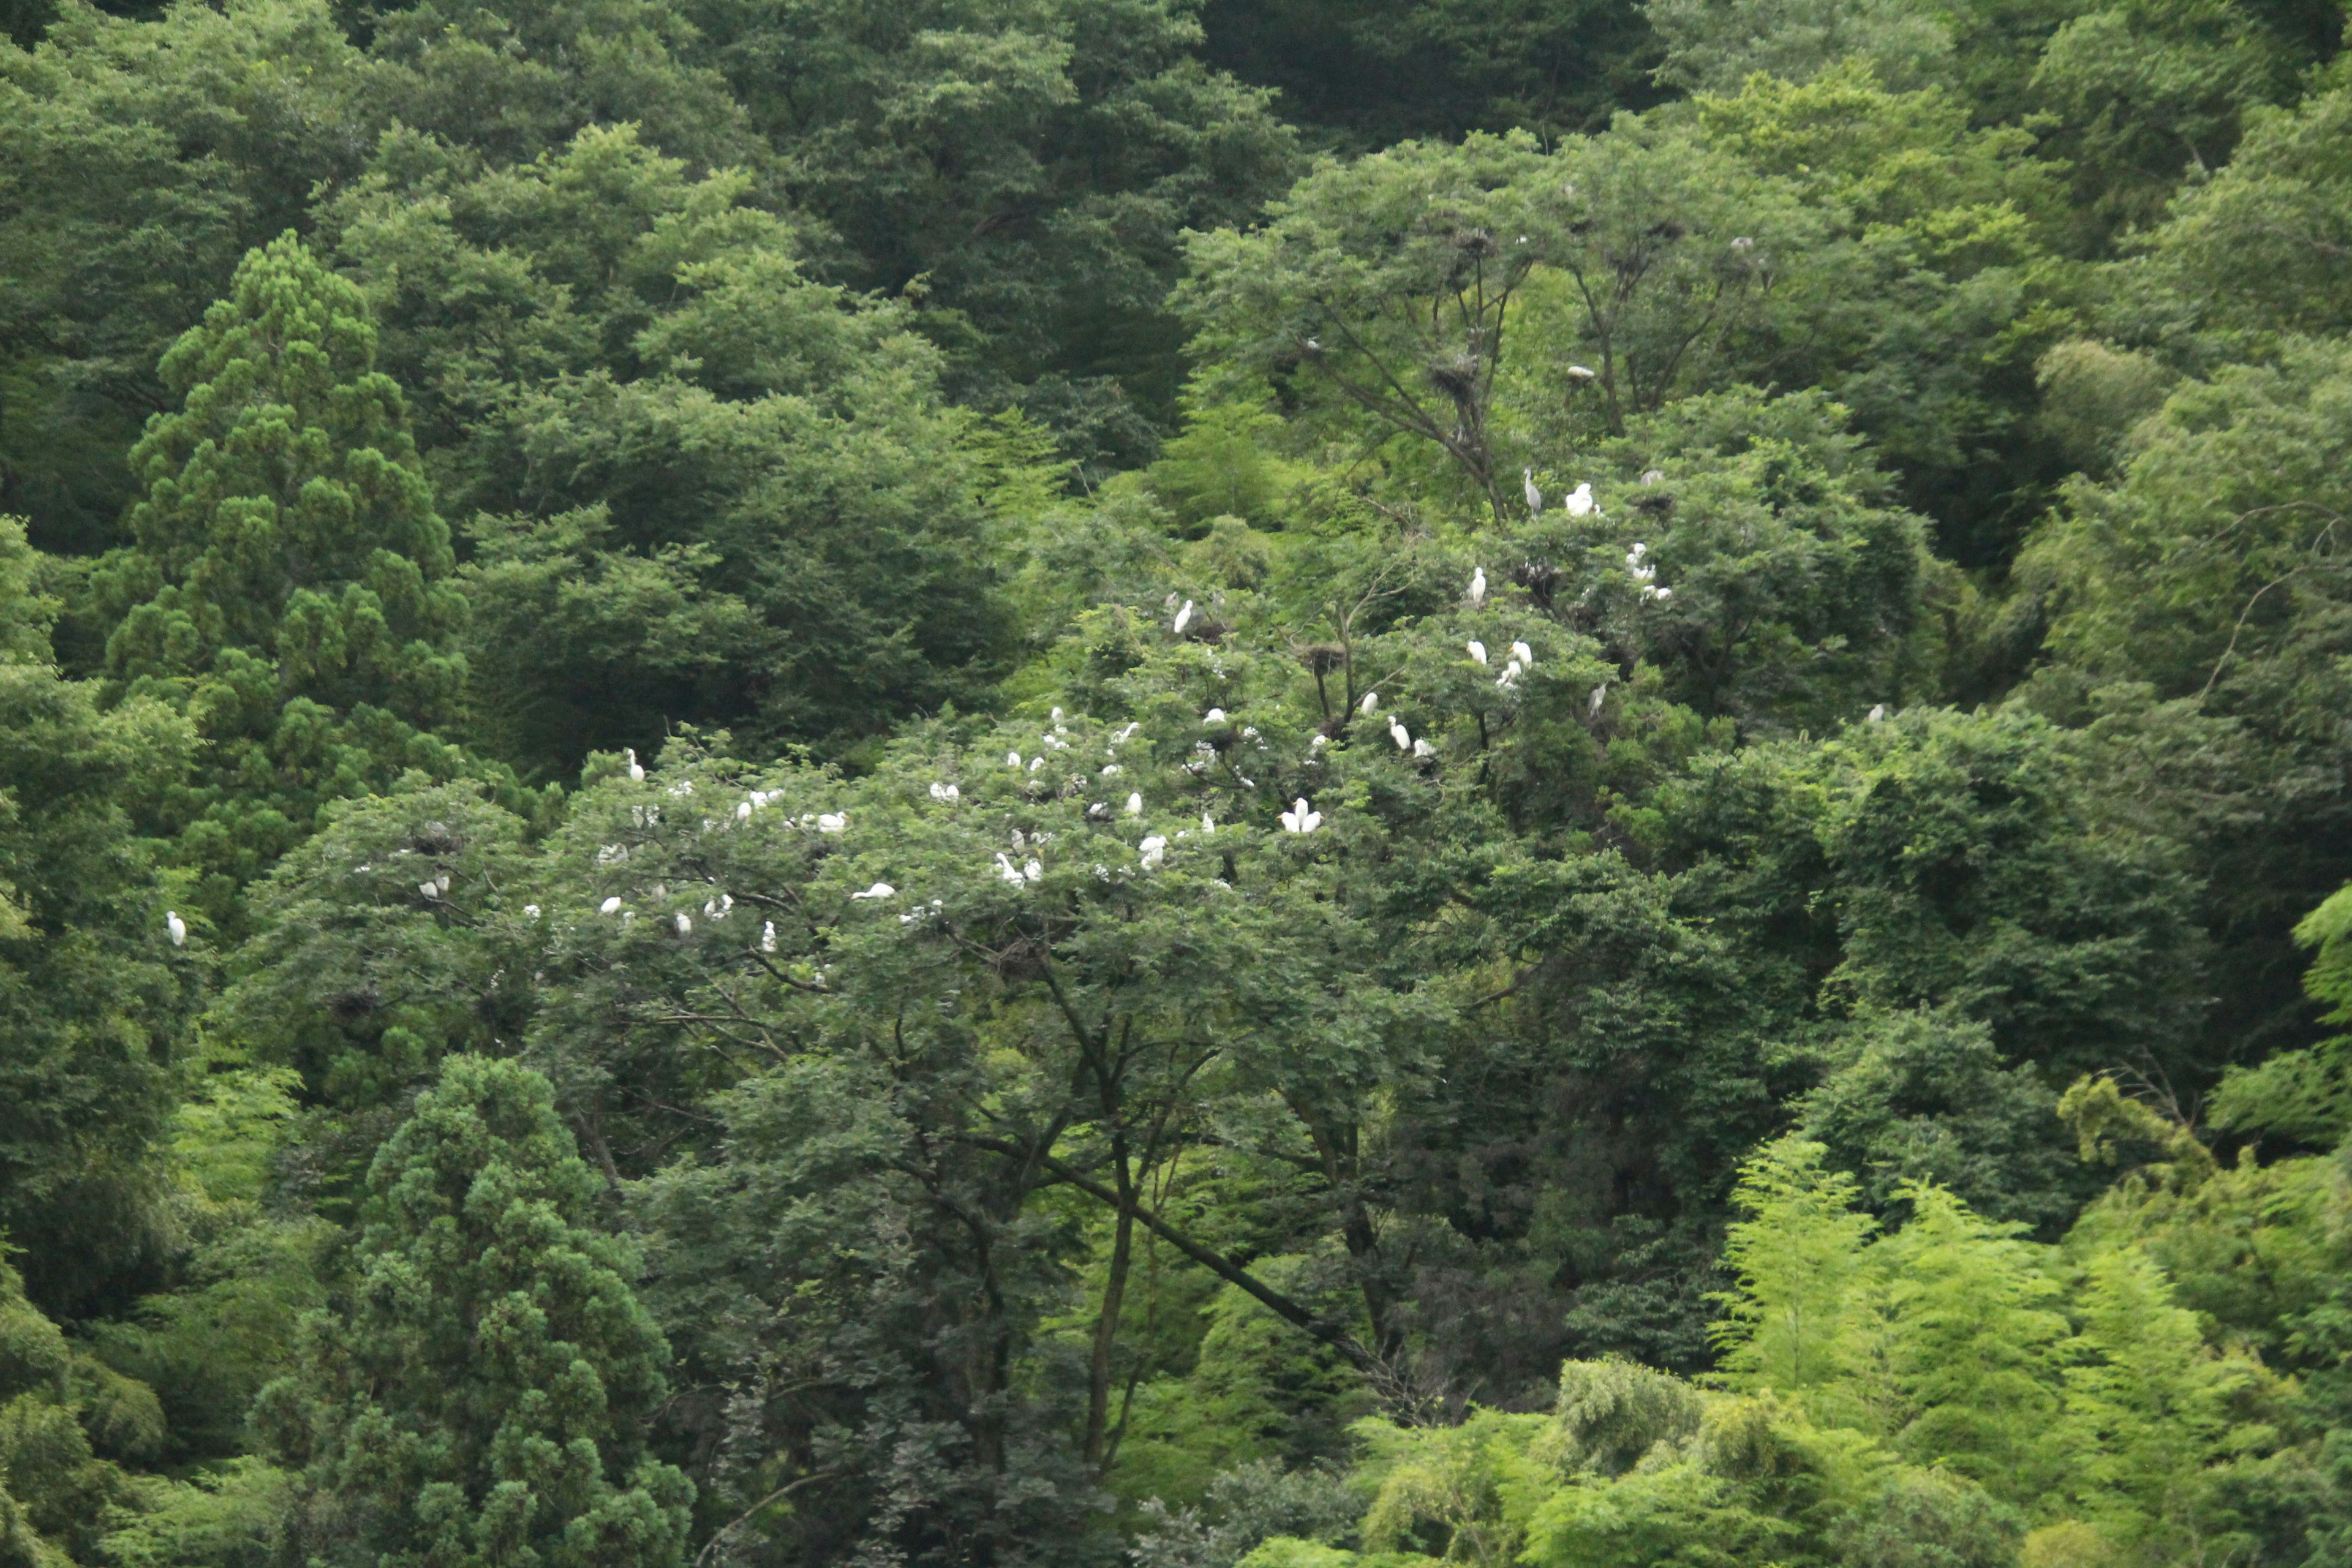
[258,1055,694,1568]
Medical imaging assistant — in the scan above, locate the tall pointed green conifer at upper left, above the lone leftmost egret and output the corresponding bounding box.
[101,235,482,912]
